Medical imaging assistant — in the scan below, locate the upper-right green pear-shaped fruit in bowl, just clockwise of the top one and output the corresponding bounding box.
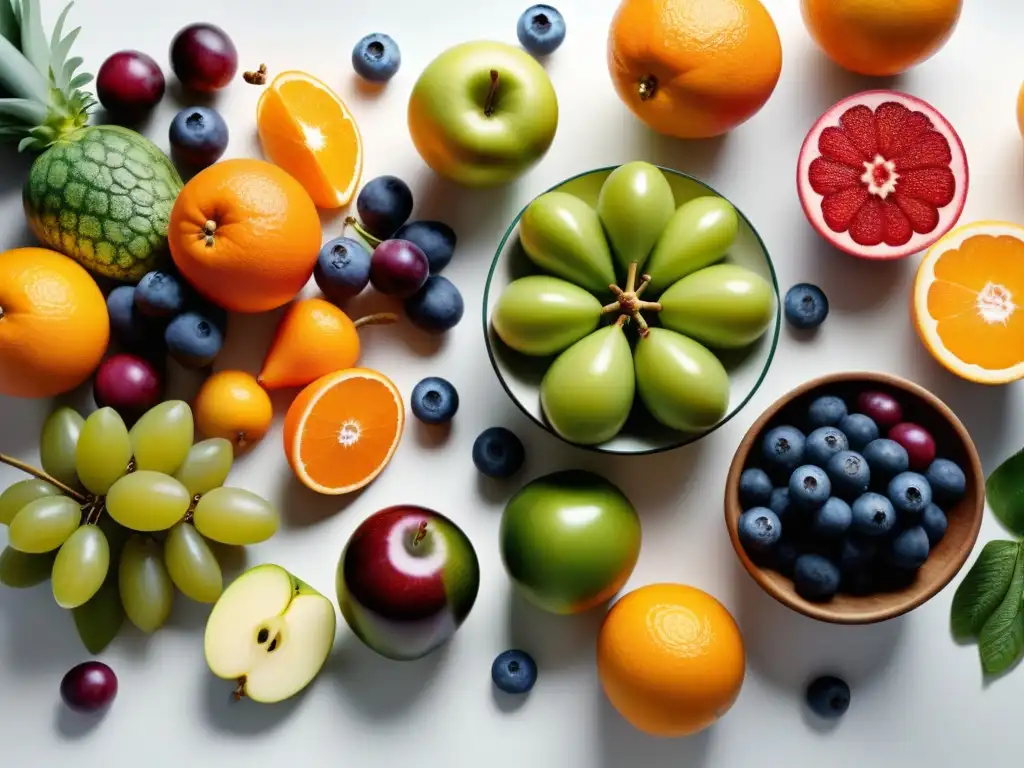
[646,196,739,294]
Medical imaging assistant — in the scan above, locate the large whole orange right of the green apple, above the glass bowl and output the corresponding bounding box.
[608,0,782,138]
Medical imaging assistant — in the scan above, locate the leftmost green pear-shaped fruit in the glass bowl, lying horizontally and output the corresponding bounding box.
[490,274,601,356]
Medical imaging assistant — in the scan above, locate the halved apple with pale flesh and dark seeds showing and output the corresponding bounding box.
[205,564,337,703]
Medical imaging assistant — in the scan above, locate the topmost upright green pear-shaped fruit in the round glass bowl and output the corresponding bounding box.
[597,161,676,272]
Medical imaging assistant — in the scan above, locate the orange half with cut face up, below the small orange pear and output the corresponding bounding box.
[285,368,406,496]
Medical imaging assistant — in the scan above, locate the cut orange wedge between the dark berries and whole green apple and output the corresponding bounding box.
[256,72,362,208]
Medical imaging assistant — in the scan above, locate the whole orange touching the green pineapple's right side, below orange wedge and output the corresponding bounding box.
[167,159,321,312]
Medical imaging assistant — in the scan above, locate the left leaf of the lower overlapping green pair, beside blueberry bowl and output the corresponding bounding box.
[949,542,1021,640]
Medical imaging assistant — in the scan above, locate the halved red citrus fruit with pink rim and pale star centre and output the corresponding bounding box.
[797,91,968,259]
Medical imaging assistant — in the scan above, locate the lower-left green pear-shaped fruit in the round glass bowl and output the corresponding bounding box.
[541,325,636,445]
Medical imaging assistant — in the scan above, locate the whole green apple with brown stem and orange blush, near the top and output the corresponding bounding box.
[409,41,558,186]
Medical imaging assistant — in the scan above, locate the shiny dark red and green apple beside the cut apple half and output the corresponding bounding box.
[337,505,480,660]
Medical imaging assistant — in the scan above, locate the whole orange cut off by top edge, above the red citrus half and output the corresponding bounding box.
[801,0,964,76]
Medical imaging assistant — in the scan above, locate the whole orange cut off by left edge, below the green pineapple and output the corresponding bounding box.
[0,248,111,397]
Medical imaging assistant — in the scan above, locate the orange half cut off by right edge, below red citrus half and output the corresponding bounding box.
[913,221,1024,384]
